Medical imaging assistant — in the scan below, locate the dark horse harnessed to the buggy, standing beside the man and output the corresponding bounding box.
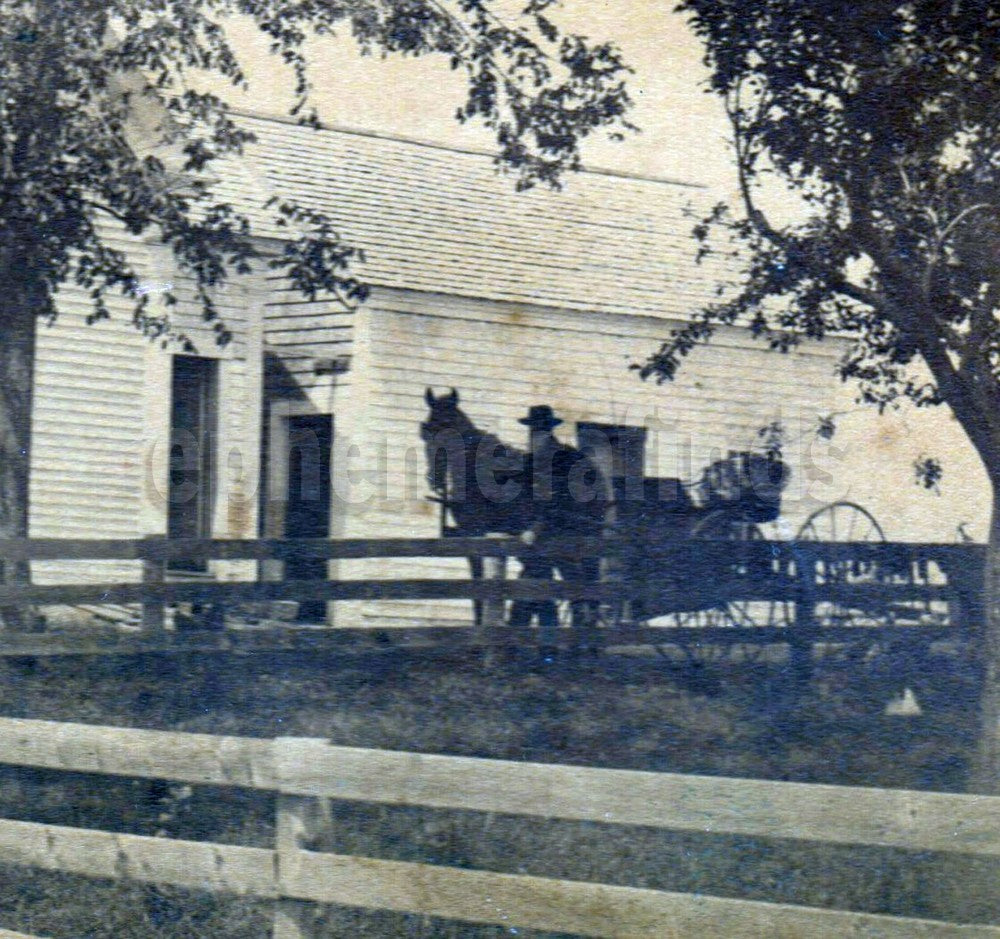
[420,388,607,624]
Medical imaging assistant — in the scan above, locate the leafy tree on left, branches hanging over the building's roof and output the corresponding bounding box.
[0,0,629,625]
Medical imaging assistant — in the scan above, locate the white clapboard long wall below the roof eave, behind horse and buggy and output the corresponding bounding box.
[324,290,837,626]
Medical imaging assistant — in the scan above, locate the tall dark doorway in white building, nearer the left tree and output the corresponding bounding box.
[167,355,216,572]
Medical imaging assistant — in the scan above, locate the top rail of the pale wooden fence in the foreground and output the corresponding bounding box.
[0,718,1000,857]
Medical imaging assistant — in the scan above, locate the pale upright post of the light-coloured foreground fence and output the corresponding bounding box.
[271,737,332,939]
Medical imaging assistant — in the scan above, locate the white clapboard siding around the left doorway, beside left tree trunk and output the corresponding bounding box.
[30,223,261,583]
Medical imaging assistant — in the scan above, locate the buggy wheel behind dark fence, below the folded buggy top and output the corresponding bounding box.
[670,509,792,662]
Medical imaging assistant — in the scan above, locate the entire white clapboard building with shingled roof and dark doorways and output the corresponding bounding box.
[25,116,988,625]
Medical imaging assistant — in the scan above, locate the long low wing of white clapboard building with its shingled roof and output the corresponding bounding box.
[240,119,986,624]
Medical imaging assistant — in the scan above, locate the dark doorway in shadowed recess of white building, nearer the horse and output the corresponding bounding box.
[285,414,333,623]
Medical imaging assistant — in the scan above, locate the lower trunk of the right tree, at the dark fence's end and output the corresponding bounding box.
[968,479,1000,795]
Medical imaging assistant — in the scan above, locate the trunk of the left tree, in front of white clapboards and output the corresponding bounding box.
[0,280,37,630]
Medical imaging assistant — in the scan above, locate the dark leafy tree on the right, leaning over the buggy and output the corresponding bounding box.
[641,0,1000,792]
